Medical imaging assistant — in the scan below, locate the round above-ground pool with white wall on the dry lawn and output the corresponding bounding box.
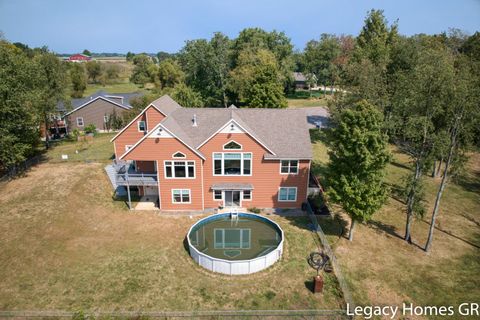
[187,213,283,275]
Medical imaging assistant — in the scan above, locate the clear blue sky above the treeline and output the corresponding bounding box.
[0,0,480,53]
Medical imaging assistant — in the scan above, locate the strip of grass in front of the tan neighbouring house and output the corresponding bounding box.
[46,133,116,162]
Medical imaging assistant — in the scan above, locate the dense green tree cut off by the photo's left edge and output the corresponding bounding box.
[0,41,42,170]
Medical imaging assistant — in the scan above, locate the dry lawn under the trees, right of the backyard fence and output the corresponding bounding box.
[312,134,480,318]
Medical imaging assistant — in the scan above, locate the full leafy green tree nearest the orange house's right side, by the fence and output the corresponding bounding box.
[327,101,390,241]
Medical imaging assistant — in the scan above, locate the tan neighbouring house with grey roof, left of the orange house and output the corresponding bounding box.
[57,91,140,132]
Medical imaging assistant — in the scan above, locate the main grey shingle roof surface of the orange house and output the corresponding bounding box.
[160,96,312,159]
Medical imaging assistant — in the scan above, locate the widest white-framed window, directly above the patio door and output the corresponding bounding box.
[213,153,252,176]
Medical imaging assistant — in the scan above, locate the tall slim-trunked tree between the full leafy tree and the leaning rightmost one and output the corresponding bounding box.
[392,39,453,242]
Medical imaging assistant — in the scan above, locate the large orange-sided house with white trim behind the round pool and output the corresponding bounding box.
[112,95,312,211]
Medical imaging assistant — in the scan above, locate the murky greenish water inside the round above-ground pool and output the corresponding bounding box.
[189,214,282,261]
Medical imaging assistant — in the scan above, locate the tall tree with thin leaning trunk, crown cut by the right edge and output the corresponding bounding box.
[425,56,480,252]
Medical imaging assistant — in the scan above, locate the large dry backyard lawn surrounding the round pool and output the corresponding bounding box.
[0,139,343,311]
